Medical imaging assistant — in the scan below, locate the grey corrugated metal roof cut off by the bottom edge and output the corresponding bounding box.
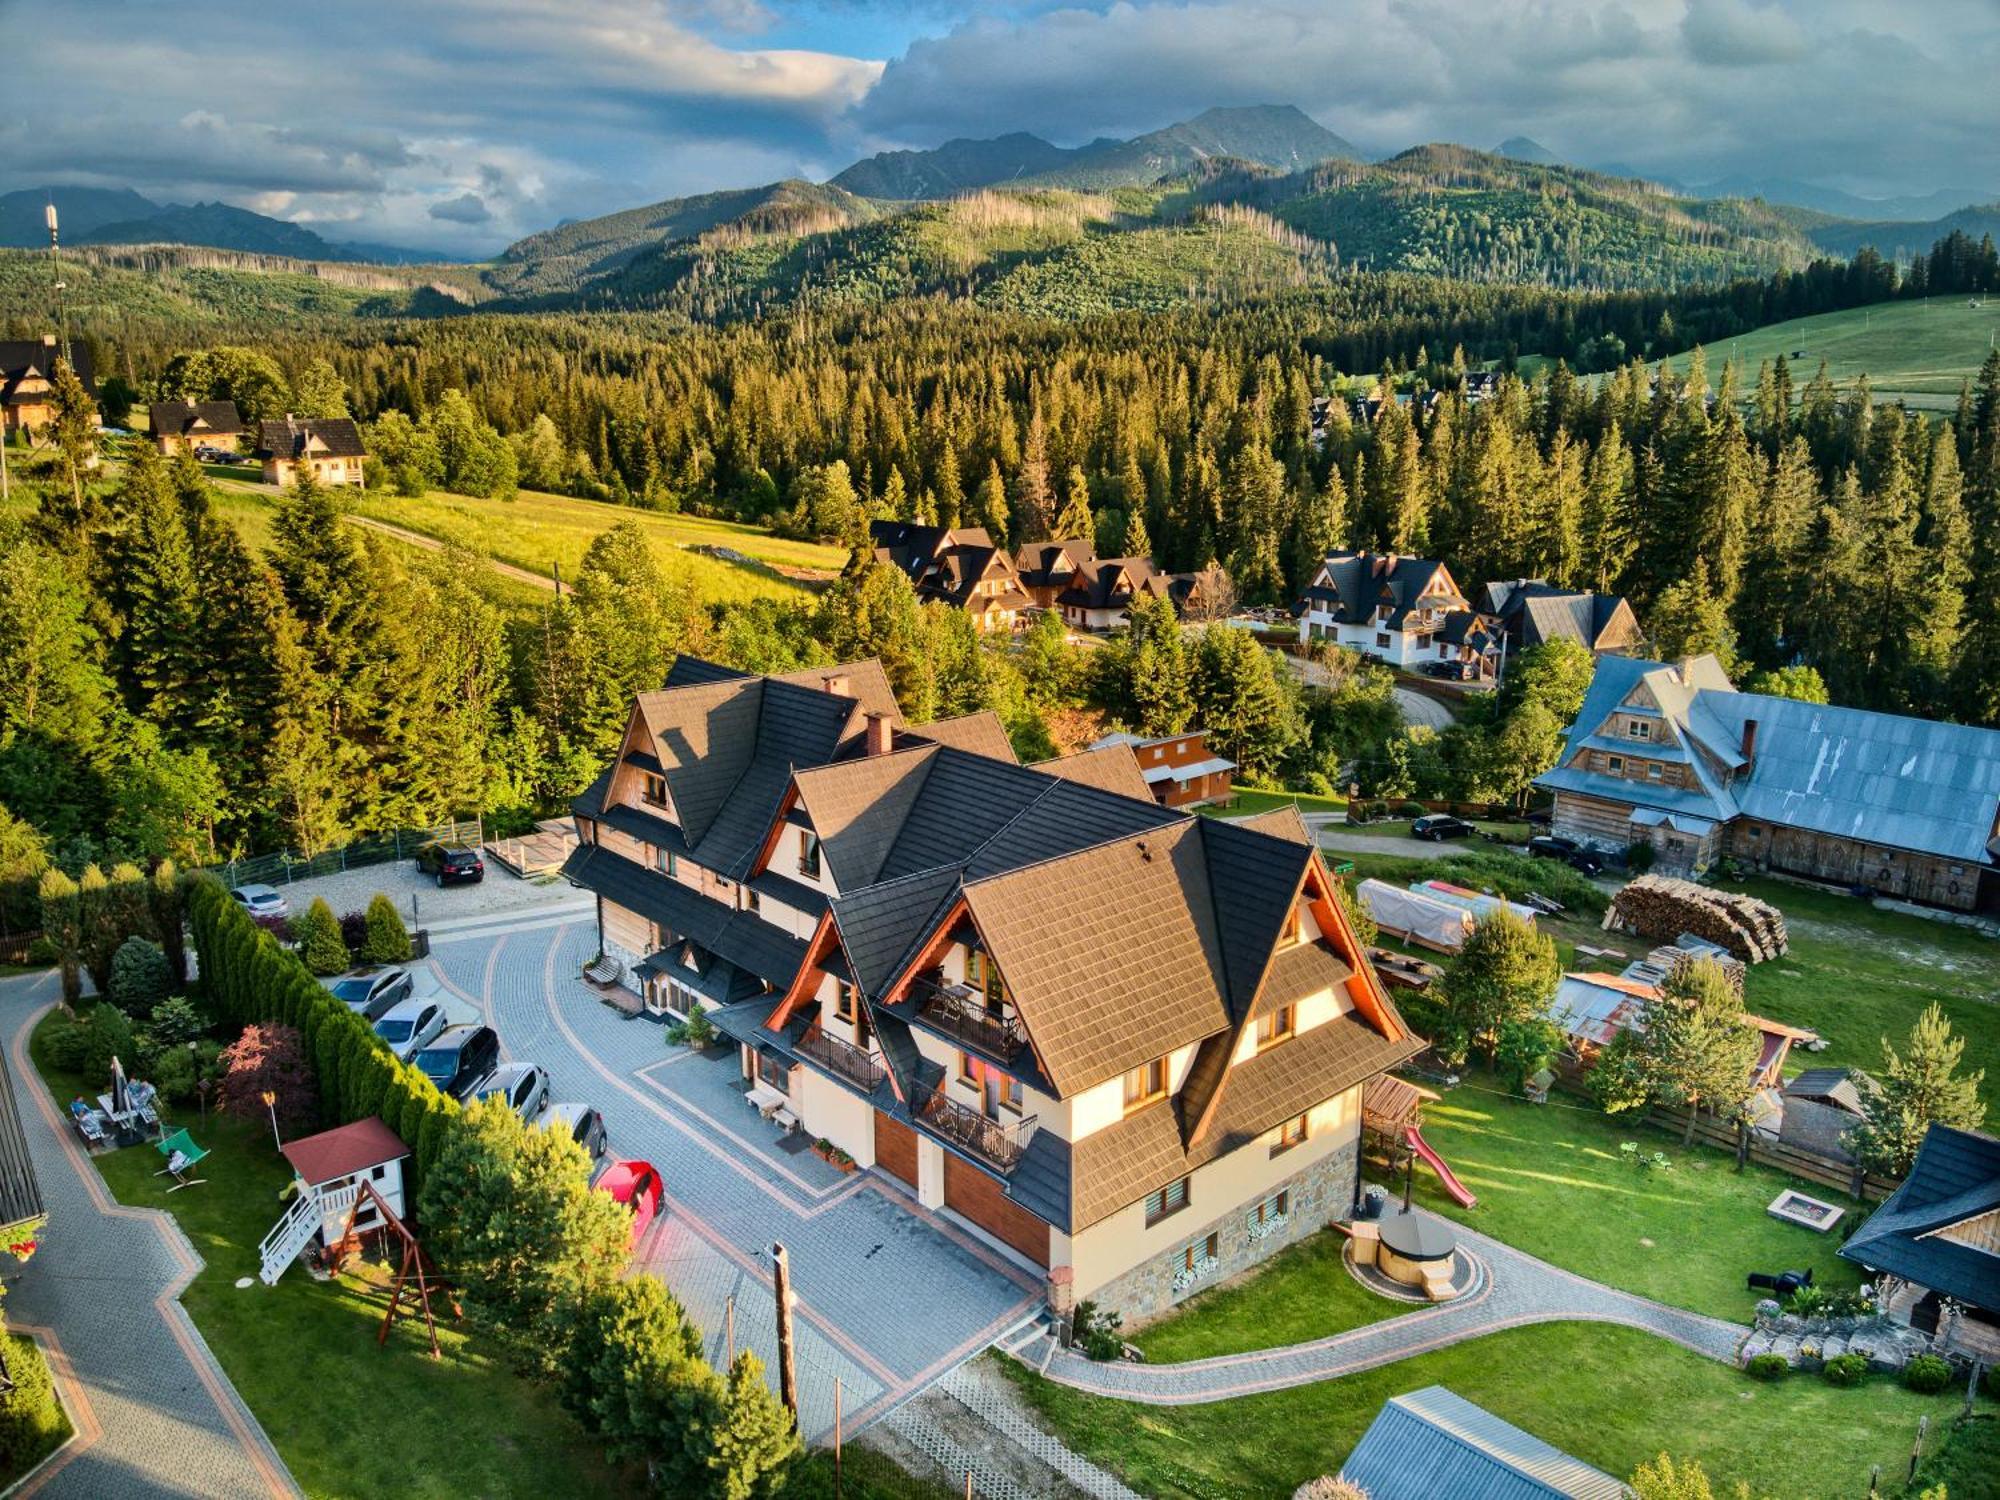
[1340,1386,1626,1500]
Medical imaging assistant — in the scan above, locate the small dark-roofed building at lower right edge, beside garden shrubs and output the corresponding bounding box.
[1840,1122,2000,1364]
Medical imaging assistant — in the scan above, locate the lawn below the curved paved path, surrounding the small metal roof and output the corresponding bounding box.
[1002,1322,1994,1500]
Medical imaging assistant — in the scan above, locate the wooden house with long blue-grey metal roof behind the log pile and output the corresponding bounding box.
[1536,656,2000,910]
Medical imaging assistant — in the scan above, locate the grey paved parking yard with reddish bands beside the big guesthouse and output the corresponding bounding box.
[428,918,1042,1438]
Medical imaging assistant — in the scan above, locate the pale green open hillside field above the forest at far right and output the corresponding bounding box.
[1668,296,2000,408]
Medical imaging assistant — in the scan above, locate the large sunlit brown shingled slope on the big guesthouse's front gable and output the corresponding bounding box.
[966,818,1230,1098]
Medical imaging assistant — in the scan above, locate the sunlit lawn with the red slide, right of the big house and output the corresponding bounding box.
[1416,1072,1860,1322]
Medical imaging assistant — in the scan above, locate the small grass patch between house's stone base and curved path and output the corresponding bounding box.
[1132,1230,1410,1364]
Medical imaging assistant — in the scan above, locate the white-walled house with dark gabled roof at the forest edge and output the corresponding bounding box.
[1296,552,1502,680]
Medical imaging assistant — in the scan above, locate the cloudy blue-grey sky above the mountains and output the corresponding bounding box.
[0,0,2000,256]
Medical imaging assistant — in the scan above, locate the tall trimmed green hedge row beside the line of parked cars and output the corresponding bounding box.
[188,874,460,1200]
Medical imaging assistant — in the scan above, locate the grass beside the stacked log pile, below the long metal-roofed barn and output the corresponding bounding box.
[1730,880,2000,1114]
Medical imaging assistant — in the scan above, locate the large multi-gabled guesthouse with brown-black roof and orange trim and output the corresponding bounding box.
[564,658,1424,1318]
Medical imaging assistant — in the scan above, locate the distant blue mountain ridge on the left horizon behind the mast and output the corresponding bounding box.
[0,188,436,266]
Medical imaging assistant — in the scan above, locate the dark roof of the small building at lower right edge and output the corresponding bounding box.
[1840,1122,2000,1312]
